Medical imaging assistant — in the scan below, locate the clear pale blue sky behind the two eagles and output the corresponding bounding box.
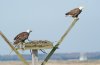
[0,0,100,55]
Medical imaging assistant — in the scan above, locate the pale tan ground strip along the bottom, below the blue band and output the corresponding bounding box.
[0,61,100,65]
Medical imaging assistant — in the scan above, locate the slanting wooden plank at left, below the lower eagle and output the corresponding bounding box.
[0,31,29,65]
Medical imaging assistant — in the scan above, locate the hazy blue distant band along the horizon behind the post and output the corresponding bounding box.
[0,52,100,61]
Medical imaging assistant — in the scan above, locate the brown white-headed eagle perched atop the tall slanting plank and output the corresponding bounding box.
[65,6,83,18]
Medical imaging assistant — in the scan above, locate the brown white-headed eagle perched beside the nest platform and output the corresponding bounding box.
[14,30,32,44]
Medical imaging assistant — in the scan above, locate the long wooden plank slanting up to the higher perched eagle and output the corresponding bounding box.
[41,18,78,65]
